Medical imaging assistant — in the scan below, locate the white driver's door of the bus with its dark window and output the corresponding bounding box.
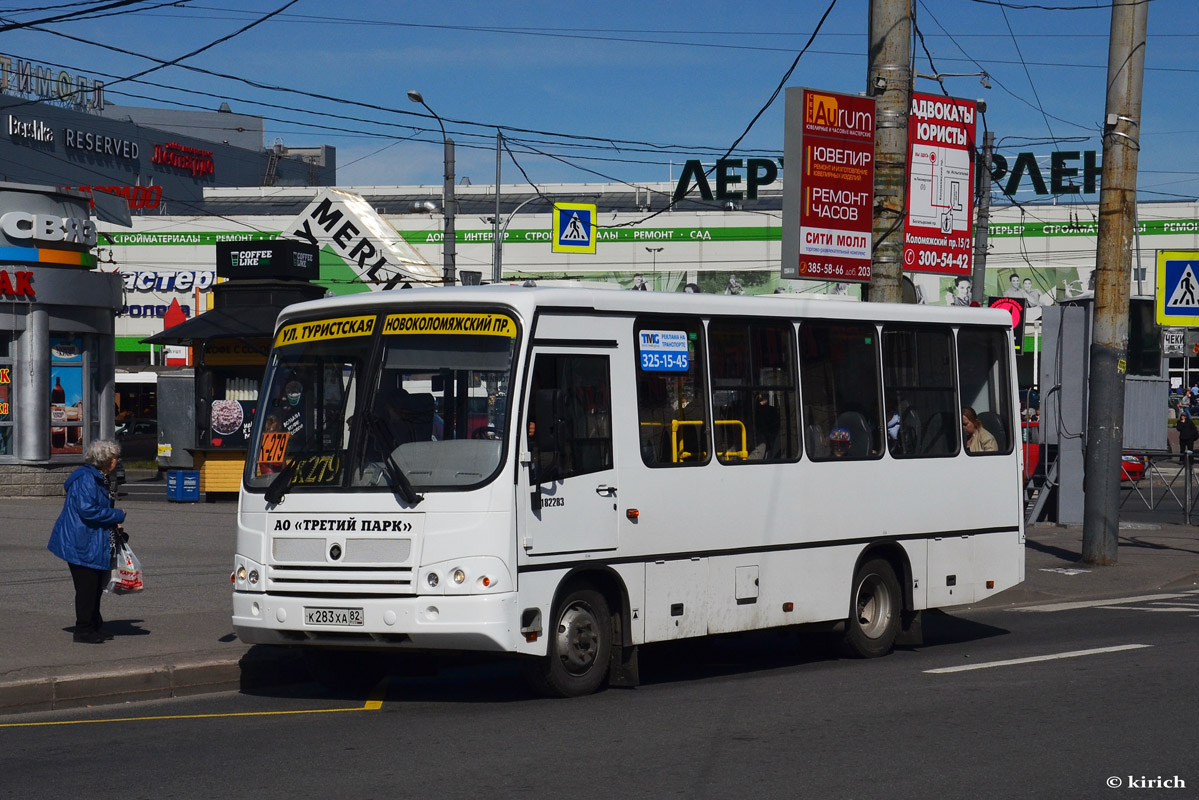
[517,348,620,555]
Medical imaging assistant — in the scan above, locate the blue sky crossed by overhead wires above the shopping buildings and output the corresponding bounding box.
[0,0,1199,206]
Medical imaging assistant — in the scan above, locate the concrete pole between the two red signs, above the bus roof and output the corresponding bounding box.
[866,0,911,302]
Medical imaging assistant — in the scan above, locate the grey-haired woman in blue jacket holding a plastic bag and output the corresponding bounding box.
[48,439,125,644]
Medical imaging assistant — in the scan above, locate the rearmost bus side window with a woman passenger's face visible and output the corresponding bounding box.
[958,327,1016,456]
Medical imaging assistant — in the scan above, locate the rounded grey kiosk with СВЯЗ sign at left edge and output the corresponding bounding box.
[0,184,121,497]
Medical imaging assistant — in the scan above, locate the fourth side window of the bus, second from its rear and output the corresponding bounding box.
[882,325,958,458]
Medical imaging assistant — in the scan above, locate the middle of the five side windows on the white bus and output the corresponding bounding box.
[800,321,884,461]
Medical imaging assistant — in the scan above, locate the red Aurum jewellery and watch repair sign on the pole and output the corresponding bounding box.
[782,88,874,282]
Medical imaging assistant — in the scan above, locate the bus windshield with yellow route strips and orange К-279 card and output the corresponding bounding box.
[246,313,517,491]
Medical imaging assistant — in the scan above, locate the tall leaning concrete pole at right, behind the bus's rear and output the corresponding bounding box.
[1083,0,1149,565]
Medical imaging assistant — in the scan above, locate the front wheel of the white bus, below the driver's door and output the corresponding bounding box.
[529,589,613,697]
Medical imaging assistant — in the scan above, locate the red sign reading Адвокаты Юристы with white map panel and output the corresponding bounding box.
[903,94,975,275]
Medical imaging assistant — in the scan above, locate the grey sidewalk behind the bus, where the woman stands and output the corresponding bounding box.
[0,481,1199,715]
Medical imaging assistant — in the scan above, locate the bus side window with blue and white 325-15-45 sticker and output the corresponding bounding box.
[634,317,711,467]
